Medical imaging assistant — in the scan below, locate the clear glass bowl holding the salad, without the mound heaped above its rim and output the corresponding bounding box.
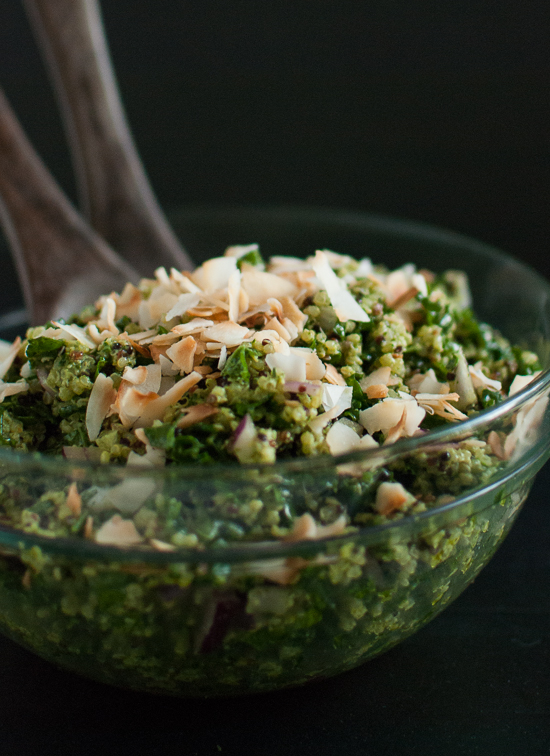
[0,208,550,697]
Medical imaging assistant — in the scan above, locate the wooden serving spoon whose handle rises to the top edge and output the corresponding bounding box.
[24,0,194,276]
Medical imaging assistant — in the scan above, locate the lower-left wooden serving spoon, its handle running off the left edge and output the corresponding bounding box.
[0,89,139,325]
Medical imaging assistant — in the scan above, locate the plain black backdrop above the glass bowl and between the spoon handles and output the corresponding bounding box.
[0,0,550,275]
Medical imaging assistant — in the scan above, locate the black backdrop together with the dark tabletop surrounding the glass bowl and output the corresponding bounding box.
[0,0,550,756]
